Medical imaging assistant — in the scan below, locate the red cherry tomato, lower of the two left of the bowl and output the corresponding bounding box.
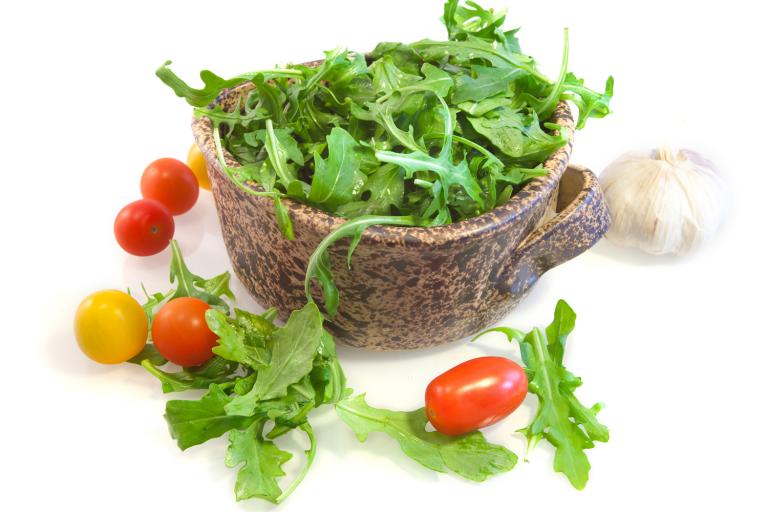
[115,199,174,256]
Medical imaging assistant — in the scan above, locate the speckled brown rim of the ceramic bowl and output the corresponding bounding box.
[192,80,575,246]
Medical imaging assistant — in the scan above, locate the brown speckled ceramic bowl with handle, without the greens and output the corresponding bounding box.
[192,73,610,350]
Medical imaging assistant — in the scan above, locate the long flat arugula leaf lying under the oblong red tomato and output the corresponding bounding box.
[336,395,517,482]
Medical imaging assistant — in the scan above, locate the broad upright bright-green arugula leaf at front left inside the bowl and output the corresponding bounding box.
[309,127,365,209]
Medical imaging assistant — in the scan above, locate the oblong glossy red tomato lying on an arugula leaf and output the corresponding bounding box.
[425,357,528,436]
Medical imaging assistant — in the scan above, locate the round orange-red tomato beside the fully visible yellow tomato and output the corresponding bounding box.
[152,297,219,366]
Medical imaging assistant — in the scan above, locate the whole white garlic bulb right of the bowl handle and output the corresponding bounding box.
[600,147,725,254]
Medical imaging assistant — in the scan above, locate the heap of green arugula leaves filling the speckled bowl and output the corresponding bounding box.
[157,0,613,238]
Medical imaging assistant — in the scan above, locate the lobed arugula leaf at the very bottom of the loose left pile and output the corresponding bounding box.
[224,421,292,503]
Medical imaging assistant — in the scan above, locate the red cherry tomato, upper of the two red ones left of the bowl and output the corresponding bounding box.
[141,158,200,215]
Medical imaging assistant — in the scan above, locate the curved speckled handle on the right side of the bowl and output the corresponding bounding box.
[506,164,611,296]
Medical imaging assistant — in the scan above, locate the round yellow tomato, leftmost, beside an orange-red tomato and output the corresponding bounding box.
[75,290,148,364]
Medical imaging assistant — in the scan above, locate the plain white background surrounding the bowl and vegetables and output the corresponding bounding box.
[0,0,768,511]
